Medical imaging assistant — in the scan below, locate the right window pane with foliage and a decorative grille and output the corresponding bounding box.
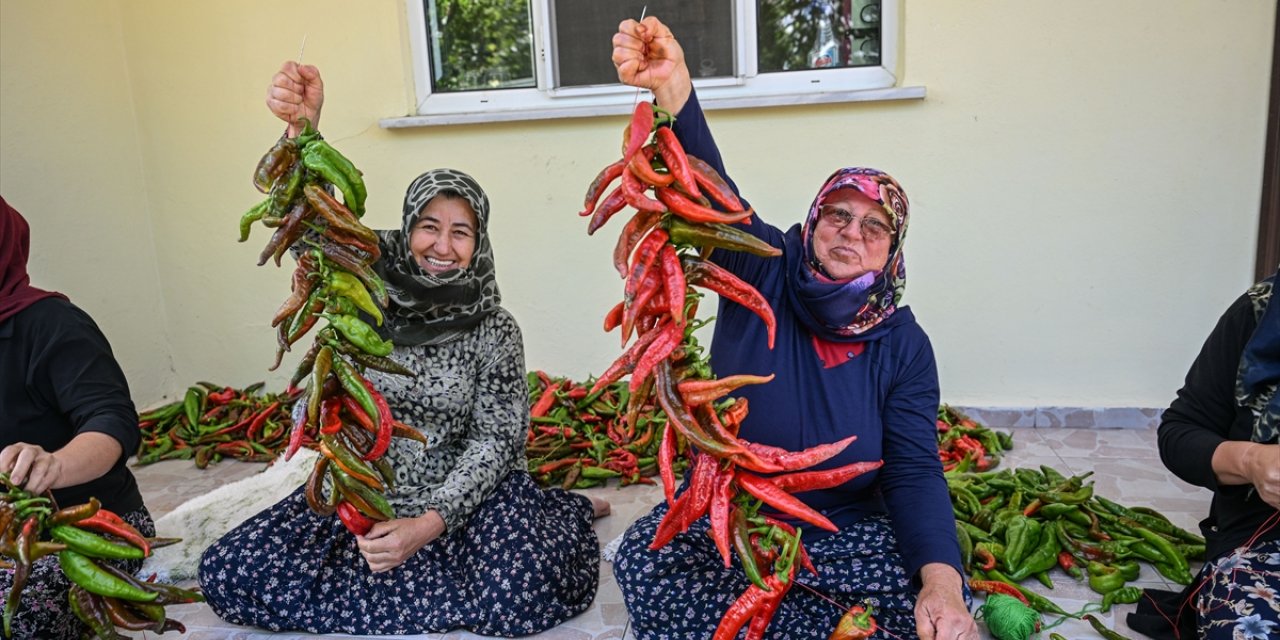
[756,0,881,73]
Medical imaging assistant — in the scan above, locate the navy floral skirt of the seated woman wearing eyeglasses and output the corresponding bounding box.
[613,502,969,640]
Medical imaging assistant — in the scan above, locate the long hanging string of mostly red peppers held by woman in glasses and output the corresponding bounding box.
[580,102,882,640]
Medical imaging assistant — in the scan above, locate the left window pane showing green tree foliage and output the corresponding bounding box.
[426,0,536,92]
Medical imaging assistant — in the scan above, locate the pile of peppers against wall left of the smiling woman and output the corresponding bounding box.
[137,381,302,468]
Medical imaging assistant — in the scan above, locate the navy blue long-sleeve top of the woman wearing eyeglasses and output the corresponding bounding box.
[673,95,964,576]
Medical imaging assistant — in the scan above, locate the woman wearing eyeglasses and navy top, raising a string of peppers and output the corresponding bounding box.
[613,17,978,640]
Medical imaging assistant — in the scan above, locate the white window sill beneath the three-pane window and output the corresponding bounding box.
[378,87,924,129]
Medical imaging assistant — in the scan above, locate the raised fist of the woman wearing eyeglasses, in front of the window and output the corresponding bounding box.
[613,15,694,113]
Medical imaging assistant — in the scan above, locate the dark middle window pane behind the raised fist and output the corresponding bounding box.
[550,0,736,87]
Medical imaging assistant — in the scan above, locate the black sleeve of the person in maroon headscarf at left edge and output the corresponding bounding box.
[32,303,141,458]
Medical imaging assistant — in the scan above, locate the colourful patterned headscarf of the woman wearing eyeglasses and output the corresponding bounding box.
[785,168,909,342]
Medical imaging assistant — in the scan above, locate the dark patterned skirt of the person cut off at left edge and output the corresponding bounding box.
[0,507,156,640]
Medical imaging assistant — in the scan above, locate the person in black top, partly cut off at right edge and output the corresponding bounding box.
[1129,271,1280,640]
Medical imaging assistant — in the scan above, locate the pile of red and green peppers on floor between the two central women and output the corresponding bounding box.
[525,371,685,489]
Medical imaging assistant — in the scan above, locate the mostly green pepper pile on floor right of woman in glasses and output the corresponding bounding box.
[945,465,1204,616]
